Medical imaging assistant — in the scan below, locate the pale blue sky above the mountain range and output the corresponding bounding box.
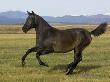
[0,0,110,16]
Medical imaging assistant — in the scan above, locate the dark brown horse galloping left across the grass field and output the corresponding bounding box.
[21,11,107,75]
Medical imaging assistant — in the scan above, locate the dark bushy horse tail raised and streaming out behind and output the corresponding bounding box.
[91,23,107,36]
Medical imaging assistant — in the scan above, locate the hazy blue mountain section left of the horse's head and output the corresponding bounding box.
[0,11,27,24]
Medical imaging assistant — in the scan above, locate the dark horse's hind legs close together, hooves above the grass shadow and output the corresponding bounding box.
[66,50,82,75]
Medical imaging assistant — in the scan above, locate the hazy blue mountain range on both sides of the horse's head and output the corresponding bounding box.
[0,11,110,24]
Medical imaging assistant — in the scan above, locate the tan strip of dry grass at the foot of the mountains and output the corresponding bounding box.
[0,24,110,34]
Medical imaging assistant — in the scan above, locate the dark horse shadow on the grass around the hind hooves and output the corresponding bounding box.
[49,64,101,74]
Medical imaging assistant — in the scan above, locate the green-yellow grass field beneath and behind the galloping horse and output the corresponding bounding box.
[0,25,110,82]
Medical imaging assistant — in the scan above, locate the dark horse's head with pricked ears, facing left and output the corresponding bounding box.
[22,11,37,33]
